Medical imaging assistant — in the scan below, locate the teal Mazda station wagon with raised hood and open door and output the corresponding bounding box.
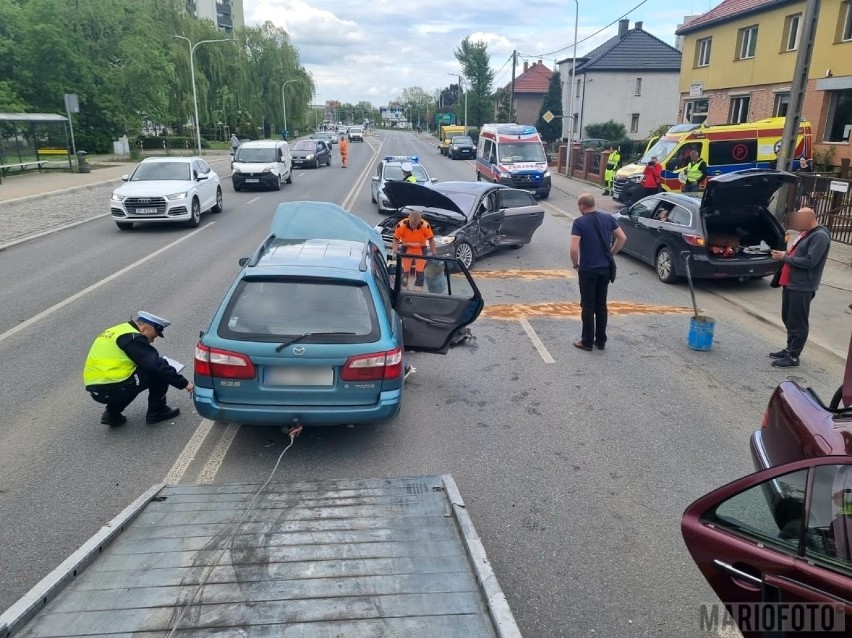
[194,202,484,427]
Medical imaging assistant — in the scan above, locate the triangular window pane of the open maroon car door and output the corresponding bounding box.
[702,470,808,552]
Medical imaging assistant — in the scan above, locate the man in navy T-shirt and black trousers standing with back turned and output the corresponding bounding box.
[571,193,627,351]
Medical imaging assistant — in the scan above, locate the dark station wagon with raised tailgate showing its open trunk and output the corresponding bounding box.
[616,169,796,283]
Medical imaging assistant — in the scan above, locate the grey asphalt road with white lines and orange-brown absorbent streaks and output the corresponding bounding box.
[0,132,841,637]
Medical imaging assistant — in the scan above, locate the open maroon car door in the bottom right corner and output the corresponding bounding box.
[681,456,852,638]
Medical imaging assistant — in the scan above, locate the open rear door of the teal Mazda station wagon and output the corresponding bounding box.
[393,254,485,354]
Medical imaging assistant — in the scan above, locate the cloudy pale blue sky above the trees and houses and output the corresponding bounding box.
[244,0,719,107]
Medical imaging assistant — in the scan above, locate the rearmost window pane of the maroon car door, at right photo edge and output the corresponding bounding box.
[805,465,852,575]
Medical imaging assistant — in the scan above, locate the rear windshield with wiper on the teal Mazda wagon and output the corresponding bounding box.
[218,278,380,343]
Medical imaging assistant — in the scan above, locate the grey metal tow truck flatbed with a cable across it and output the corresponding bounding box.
[0,475,521,638]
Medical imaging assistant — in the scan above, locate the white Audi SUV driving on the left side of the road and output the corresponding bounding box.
[110,157,222,230]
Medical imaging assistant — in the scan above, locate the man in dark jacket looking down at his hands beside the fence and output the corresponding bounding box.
[769,208,831,368]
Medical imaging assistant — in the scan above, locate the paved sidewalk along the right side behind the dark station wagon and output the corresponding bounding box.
[552,173,852,359]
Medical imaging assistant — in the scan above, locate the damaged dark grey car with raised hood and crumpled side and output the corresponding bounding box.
[376,182,544,268]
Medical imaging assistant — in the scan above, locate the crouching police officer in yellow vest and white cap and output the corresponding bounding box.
[83,311,194,426]
